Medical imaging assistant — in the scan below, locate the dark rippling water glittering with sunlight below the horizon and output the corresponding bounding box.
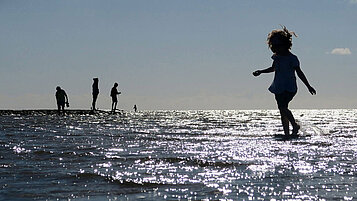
[0,110,357,200]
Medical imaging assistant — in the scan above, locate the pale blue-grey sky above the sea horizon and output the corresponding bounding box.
[0,0,357,110]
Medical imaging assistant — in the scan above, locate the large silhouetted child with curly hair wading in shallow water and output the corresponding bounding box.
[253,26,316,136]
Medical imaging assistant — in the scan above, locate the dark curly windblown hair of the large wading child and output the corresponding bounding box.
[267,26,297,50]
